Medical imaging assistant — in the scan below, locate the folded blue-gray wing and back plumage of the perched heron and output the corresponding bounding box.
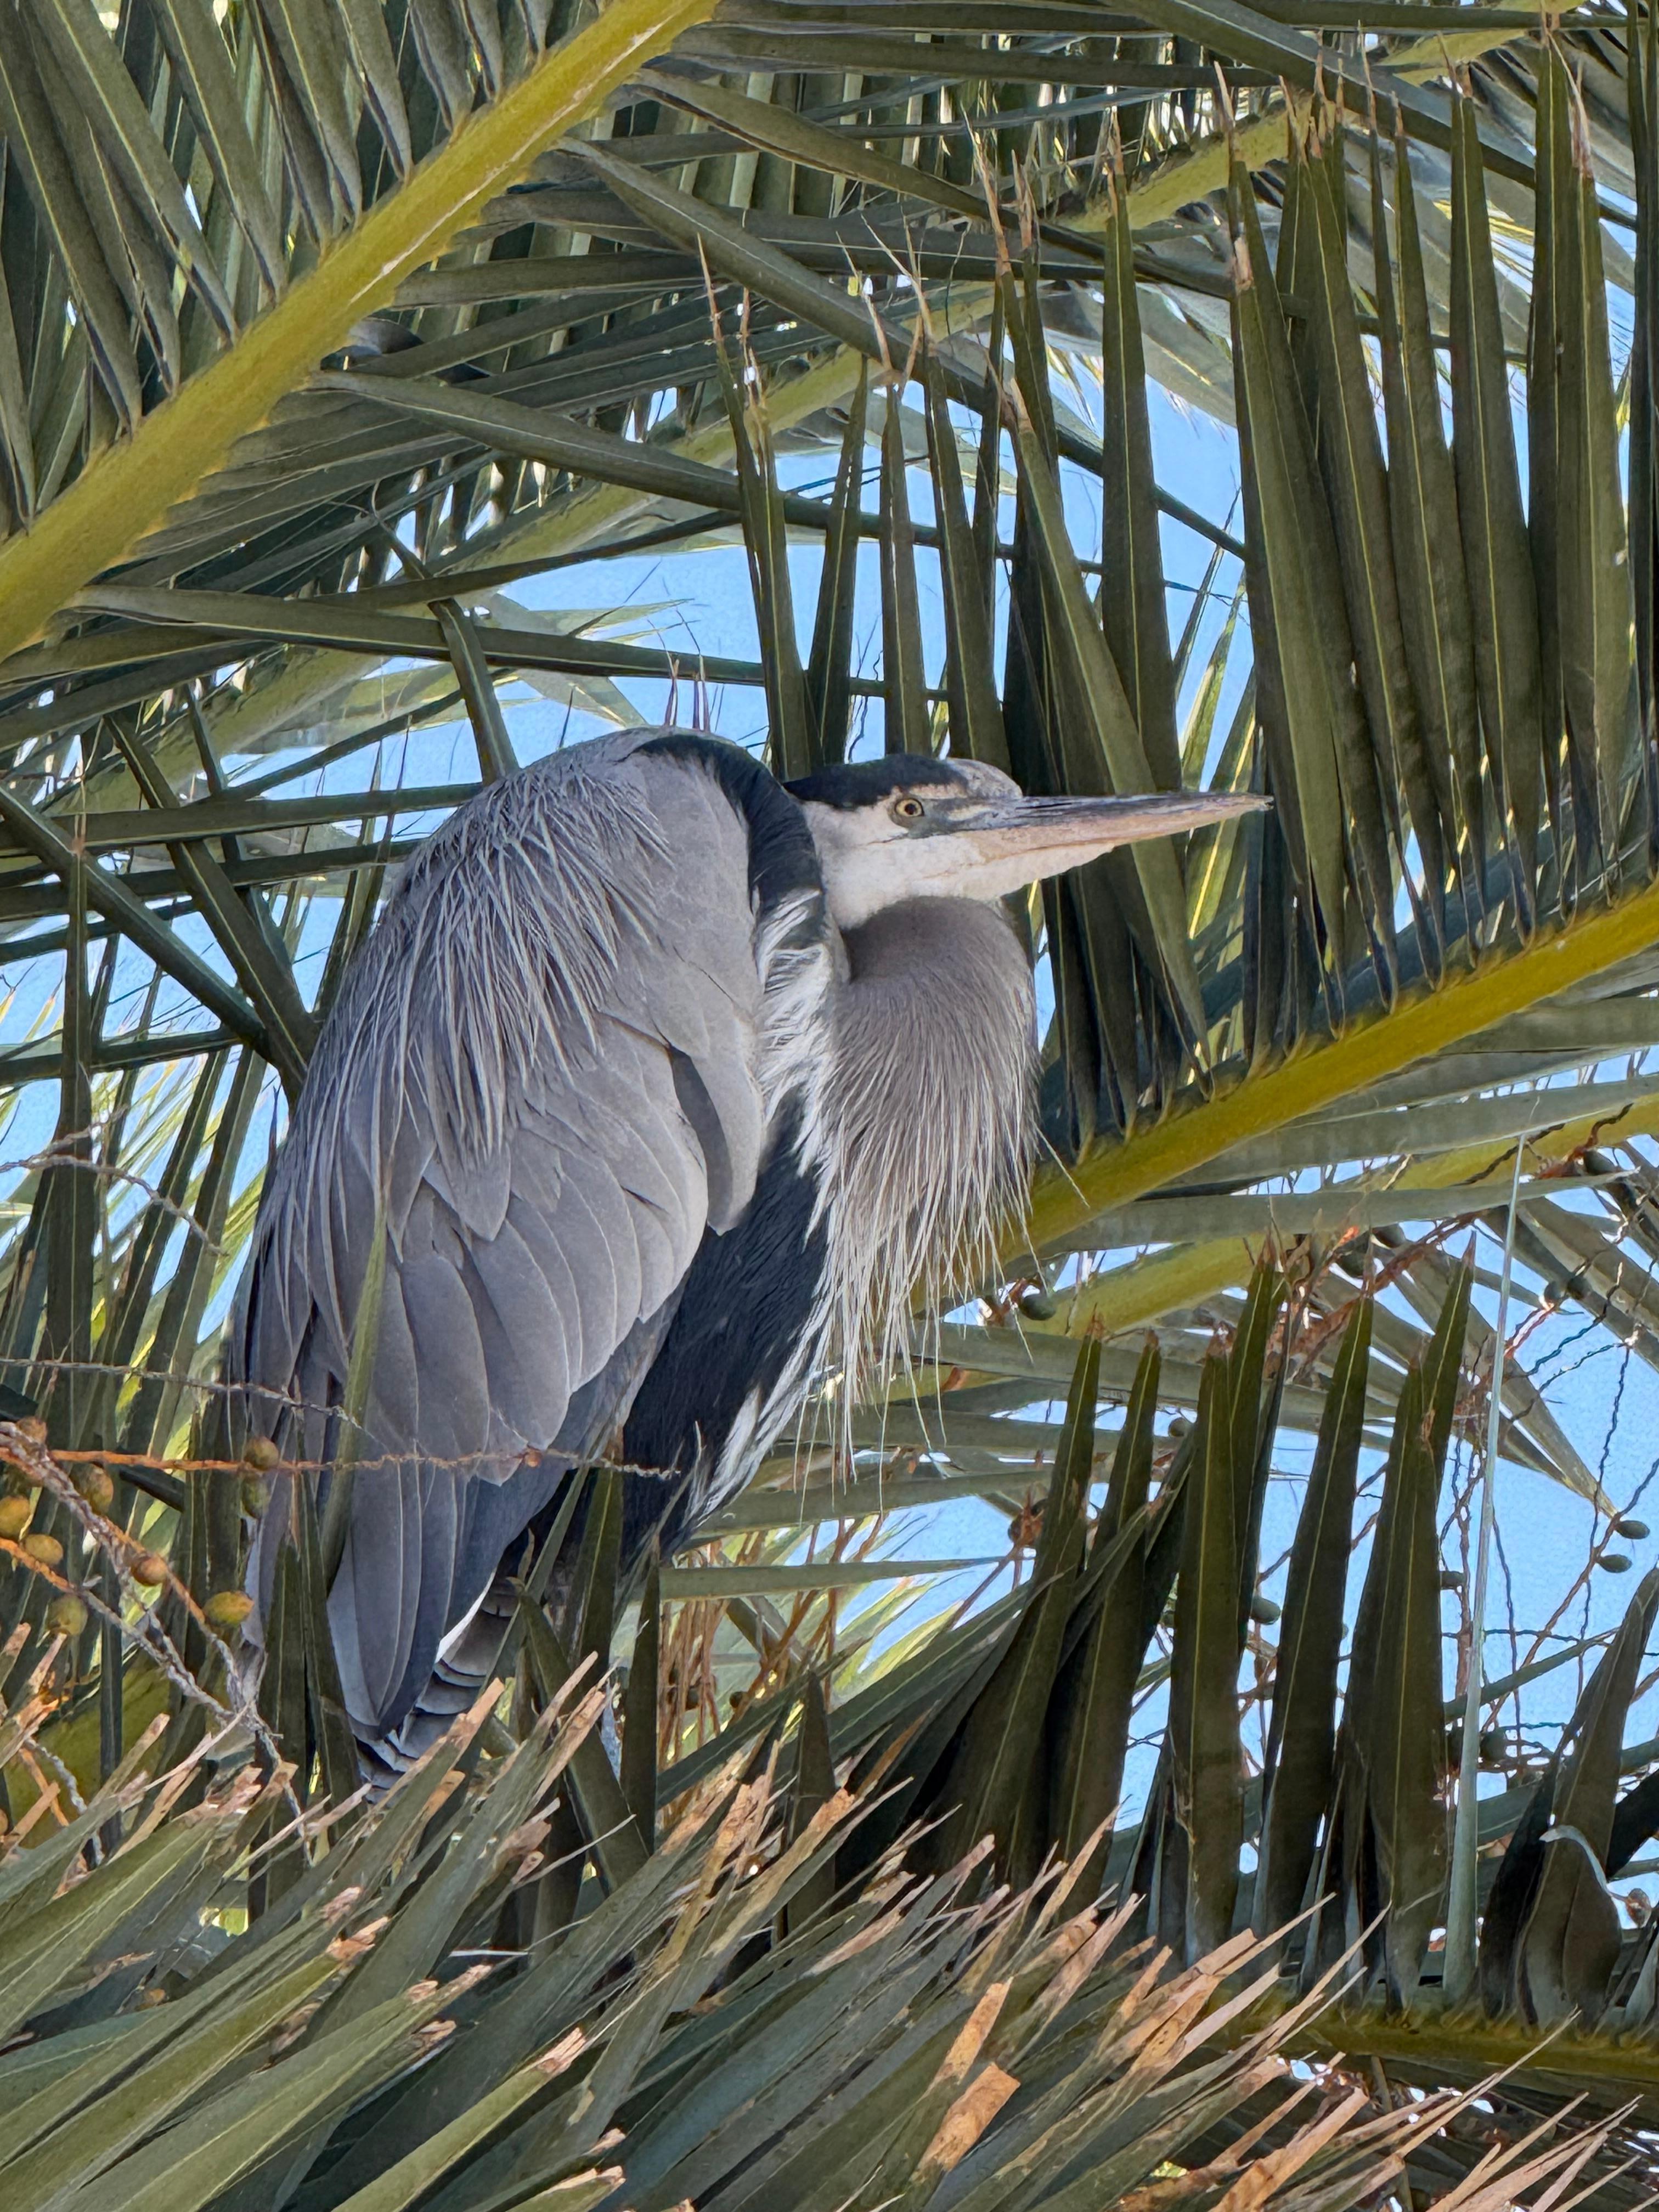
[228,732,800,1734]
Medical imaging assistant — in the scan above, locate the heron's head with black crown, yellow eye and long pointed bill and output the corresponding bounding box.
[787,752,1267,929]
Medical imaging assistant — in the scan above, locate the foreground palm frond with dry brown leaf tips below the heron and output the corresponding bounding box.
[0,1637,1628,2212]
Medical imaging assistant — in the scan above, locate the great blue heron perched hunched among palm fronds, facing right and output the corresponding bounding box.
[228,730,1259,1765]
